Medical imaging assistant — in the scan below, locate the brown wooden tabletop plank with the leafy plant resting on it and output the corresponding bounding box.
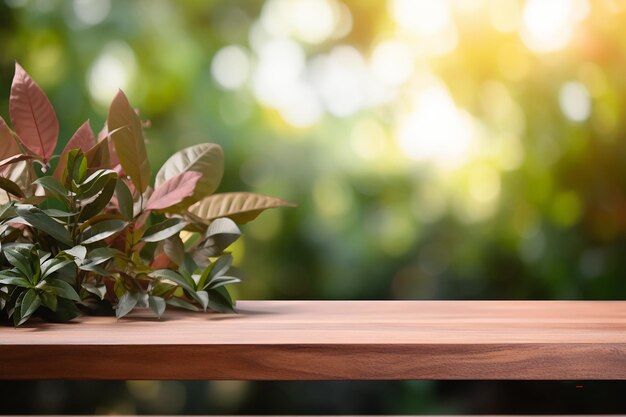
[0,301,626,380]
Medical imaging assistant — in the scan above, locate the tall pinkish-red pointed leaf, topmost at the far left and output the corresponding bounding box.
[9,63,59,163]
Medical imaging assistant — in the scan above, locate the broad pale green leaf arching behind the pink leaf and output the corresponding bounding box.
[155,143,224,207]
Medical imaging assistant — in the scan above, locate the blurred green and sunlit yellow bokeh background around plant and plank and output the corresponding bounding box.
[0,0,626,413]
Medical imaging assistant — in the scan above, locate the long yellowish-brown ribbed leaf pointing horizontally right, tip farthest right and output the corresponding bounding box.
[189,192,295,224]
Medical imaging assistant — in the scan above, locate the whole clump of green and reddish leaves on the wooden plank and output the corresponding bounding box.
[0,64,291,326]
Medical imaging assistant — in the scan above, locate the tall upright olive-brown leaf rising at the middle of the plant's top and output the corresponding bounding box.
[107,90,150,193]
